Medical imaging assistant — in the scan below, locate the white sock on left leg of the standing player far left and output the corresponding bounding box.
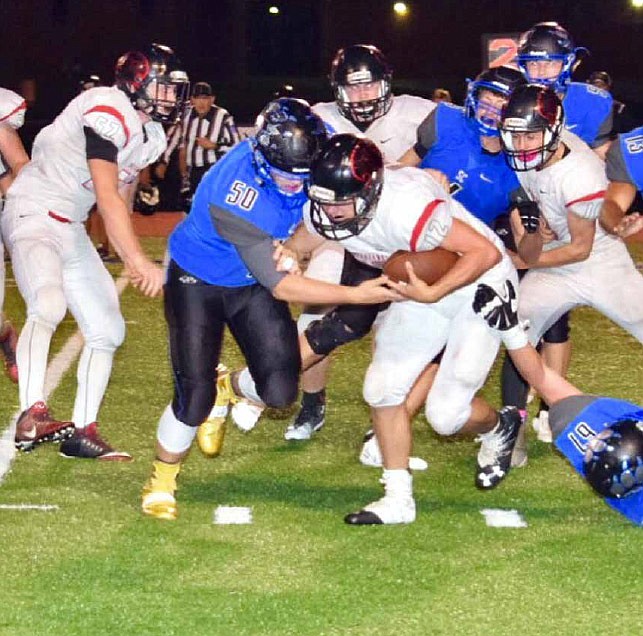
[16,319,54,411]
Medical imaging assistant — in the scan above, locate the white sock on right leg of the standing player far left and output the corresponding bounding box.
[72,346,114,428]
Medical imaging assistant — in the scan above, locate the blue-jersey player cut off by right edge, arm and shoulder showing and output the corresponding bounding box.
[600,126,643,238]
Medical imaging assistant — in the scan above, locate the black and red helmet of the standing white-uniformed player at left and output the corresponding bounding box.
[115,44,190,124]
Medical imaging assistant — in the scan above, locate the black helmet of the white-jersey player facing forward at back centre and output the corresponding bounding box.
[329,44,393,126]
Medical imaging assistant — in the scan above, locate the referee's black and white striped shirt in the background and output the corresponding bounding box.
[174,105,240,168]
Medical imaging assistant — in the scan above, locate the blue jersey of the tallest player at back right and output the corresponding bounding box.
[563,82,614,148]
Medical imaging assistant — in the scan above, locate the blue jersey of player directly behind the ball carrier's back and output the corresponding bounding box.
[420,103,520,230]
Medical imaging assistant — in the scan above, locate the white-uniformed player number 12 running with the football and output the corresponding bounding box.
[262,134,527,525]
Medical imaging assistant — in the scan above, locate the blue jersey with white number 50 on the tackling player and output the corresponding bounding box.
[169,141,306,287]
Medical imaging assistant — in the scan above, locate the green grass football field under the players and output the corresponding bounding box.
[0,239,643,636]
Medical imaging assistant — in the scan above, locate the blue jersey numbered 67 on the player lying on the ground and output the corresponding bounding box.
[556,398,643,525]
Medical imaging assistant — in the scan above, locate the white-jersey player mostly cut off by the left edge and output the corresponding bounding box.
[0,88,29,382]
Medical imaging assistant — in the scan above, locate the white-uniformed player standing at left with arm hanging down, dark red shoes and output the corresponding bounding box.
[7,45,188,460]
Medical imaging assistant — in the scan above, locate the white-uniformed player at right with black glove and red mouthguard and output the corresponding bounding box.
[500,85,643,356]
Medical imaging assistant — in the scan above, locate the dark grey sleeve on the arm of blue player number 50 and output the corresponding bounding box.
[210,205,287,291]
